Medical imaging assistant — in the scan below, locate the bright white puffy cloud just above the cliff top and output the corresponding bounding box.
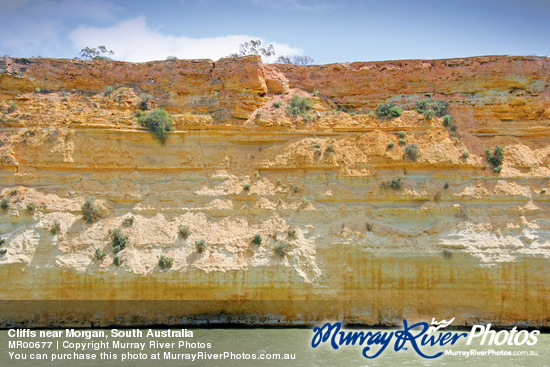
[69,17,302,62]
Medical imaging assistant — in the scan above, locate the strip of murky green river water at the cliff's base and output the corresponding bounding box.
[0,328,550,367]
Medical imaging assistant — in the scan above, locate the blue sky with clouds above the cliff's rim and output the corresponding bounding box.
[0,0,550,64]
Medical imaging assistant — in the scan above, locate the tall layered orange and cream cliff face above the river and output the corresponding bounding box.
[0,56,550,327]
